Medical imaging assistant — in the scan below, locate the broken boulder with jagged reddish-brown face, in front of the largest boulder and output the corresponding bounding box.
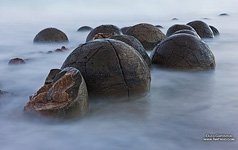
[24,67,88,117]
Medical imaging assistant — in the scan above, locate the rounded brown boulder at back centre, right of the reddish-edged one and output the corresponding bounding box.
[126,23,165,50]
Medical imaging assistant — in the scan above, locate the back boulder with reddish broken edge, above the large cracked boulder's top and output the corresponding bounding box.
[86,25,121,42]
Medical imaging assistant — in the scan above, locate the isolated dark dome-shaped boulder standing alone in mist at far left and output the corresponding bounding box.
[34,28,69,43]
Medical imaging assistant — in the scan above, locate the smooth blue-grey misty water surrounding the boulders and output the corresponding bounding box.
[0,0,238,150]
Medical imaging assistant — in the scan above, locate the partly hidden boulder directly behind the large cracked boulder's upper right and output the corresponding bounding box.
[111,35,151,67]
